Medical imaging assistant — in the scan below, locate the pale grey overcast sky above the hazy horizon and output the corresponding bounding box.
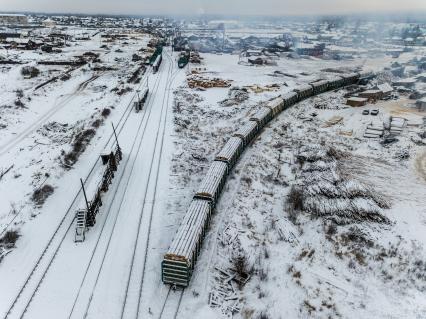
[0,0,426,15]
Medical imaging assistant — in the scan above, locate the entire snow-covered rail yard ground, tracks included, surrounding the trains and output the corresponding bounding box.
[0,18,426,319]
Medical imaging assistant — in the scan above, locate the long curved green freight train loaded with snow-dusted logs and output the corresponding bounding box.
[161,73,371,287]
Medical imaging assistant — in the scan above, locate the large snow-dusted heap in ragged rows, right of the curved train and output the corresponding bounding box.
[287,145,389,224]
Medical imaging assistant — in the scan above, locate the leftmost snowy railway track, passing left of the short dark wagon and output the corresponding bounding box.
[4,67,151,319]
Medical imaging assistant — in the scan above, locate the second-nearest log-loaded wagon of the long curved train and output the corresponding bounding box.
[194,161,228,206]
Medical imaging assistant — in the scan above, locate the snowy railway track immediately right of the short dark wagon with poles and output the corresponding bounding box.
[65,50,171,318]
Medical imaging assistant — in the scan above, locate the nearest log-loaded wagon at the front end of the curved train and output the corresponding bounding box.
[161,199,212,287]
